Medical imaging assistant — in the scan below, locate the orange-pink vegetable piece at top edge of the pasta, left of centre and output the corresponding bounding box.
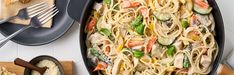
[123,0,140,8]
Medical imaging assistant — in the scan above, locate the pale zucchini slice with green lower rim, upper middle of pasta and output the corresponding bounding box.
[153,12,171,21]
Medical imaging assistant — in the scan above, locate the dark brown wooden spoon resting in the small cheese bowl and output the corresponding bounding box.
[14,58,47,75]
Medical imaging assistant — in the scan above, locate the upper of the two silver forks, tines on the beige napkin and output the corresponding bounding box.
[0,2,48,24]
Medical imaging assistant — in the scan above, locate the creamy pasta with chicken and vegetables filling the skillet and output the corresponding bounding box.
[85,0,218,75]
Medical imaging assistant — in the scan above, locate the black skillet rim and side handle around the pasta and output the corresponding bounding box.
[68,0,225,75]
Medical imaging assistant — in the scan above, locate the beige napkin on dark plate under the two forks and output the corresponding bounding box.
[0,0,54,28]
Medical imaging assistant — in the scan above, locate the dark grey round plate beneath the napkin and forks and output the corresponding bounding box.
[0,0,74,46]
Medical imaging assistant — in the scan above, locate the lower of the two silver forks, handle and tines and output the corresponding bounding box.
[0,5,59,48]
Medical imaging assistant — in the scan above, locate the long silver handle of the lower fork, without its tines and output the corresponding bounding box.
[0,25,31,48]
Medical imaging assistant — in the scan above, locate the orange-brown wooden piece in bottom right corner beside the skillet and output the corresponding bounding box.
[217,64,234,75]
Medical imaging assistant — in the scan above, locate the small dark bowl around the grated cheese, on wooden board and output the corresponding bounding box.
[24,55,64,75]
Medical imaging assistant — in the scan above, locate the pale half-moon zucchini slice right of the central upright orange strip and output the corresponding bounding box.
[158,37,175,45]
